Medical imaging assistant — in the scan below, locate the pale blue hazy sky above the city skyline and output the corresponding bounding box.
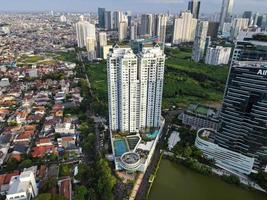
[0,0,267,14]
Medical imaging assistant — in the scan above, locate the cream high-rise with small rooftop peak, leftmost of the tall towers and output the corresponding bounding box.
[75,16,95,48]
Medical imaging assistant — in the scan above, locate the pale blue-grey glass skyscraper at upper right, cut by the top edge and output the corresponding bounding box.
[220,0,234,31]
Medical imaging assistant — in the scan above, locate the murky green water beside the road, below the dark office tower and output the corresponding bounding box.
[149,159,267,200]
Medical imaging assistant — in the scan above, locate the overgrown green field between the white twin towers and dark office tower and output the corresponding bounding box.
[163,49,228,108]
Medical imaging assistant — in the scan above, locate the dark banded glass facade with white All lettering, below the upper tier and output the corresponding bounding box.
[215,61,267,170]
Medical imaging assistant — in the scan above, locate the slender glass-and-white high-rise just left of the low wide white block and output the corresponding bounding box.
[192,21,209,62]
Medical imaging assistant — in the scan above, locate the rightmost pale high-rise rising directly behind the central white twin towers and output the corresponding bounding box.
[155,14,168,43]
